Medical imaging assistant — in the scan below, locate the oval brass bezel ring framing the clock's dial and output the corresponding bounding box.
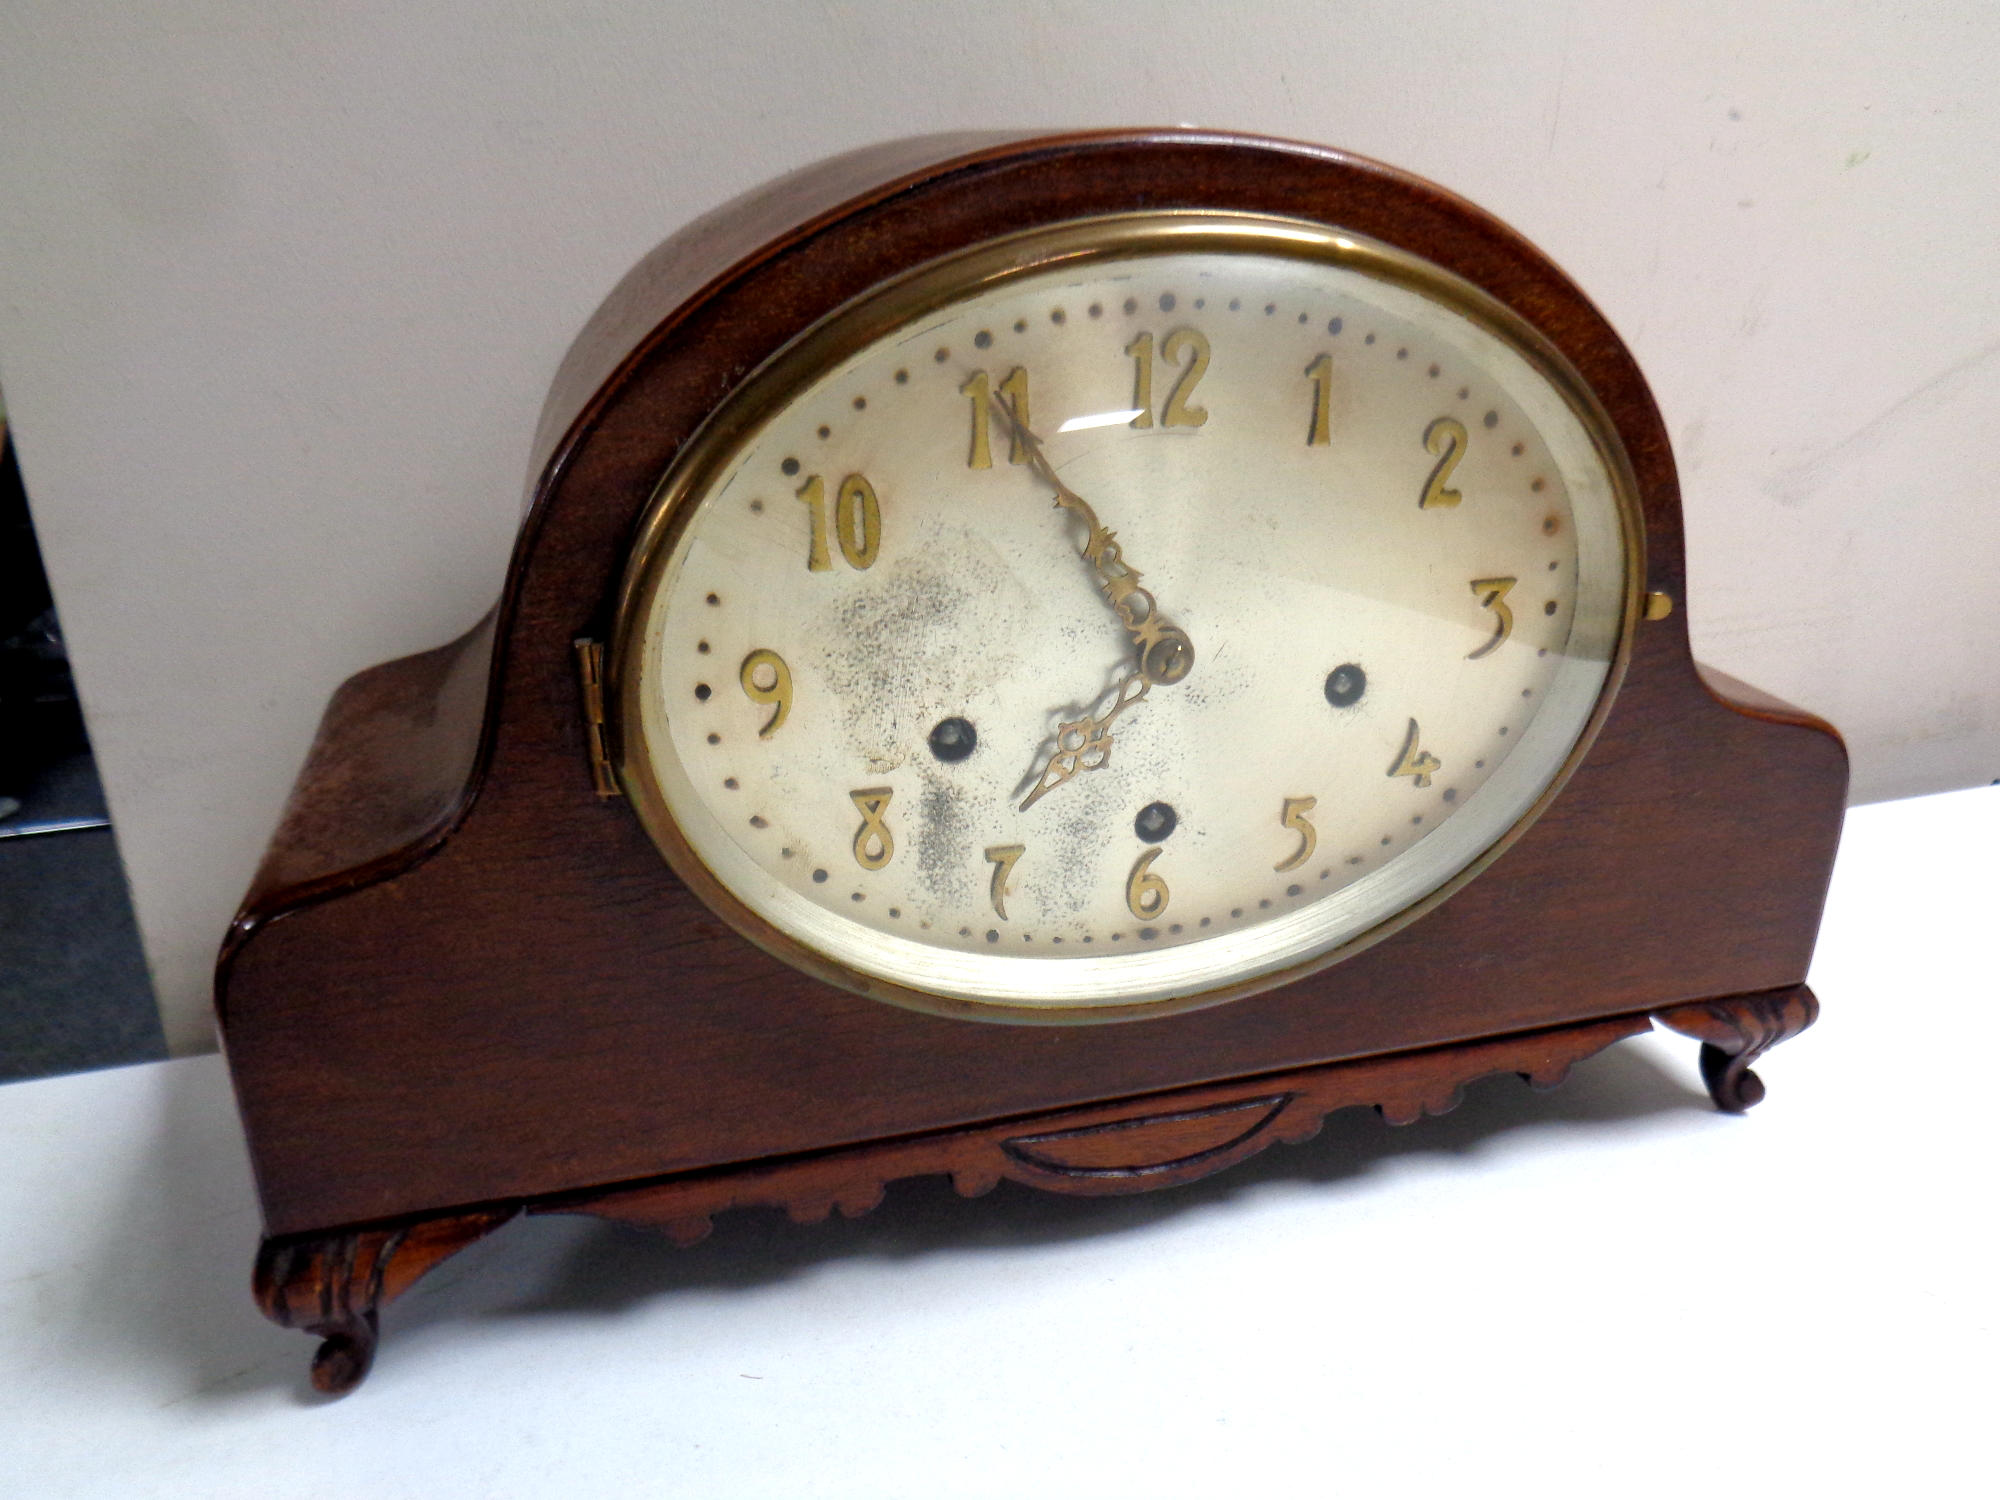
[606,210,1646,1026]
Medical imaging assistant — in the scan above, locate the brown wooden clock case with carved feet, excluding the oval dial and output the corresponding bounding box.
[216,132,1846,1390]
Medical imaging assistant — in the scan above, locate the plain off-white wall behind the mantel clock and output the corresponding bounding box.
[0,0,2000,1050]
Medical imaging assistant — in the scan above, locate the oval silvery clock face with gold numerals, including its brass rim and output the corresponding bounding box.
[614,214,1638,1016]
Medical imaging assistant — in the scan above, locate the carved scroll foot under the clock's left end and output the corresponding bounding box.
[256,1208,516,1396]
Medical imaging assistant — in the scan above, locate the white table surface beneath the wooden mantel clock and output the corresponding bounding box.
[0,788,2000,1500]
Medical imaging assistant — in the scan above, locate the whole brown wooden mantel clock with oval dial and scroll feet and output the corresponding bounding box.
[218,130,1846,1390]
